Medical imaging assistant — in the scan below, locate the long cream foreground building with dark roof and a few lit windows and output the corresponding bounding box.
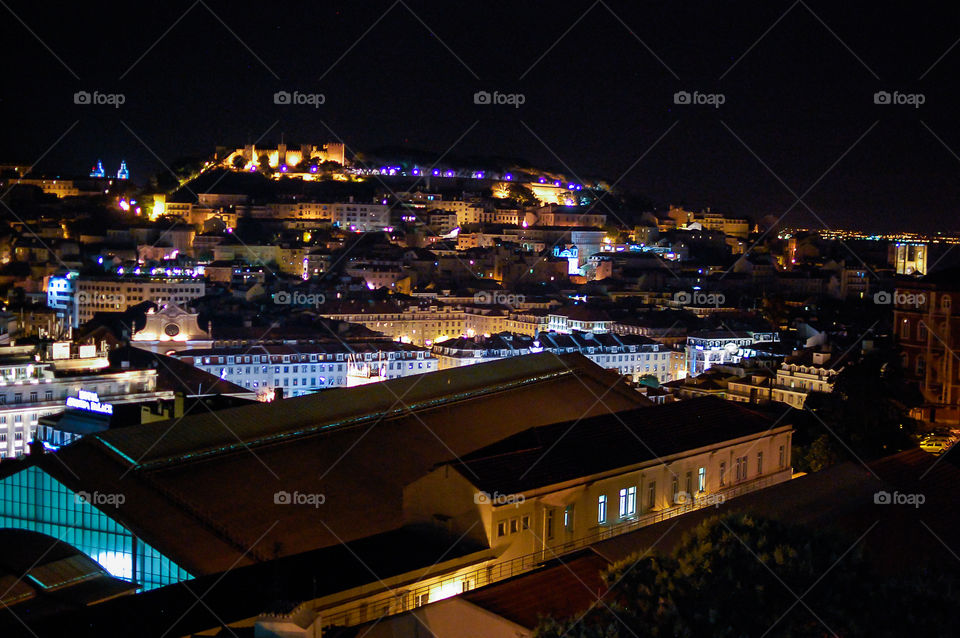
[404,397,793,562]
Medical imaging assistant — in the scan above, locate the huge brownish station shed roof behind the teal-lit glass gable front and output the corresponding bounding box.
[0,354,648,575]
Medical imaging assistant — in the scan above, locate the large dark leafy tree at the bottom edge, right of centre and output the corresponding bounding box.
[535,514,957,638]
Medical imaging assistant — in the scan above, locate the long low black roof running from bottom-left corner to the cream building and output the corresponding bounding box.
[0,527,485,638]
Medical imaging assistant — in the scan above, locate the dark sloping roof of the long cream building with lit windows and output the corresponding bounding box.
[451,397,787,494]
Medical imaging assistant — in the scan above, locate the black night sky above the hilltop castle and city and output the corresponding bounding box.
[0,0,960,231]
